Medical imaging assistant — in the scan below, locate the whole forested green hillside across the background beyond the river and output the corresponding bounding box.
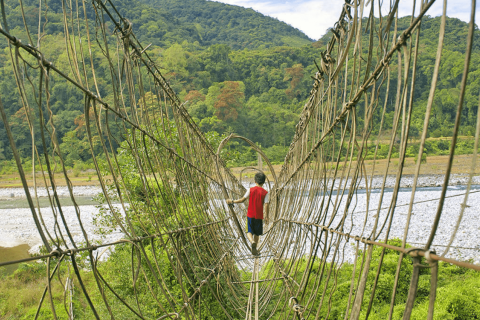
[0,0,480,166]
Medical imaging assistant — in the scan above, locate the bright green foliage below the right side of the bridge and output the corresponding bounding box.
[262,239,480,320]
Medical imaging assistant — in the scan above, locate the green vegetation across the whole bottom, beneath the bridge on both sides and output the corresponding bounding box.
[0,234,480,320]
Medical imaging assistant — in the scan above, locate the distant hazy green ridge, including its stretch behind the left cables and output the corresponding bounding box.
[0,0,313,50]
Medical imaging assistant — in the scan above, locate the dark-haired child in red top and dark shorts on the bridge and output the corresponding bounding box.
[227,172,269,255]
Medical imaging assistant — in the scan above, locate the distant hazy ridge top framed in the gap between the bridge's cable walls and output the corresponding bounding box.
[140,0,313,50]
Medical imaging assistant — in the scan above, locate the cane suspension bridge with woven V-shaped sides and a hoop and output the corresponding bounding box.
[0,0,480,319]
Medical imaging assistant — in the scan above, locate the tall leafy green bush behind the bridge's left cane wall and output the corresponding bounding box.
[89,119,239,319]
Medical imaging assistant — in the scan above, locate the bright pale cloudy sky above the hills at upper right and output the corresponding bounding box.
[215,0,480,40]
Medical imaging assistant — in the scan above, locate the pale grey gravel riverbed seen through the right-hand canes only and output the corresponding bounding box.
[327,187,480,265]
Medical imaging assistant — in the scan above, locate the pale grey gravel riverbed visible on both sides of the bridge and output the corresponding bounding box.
[0,175,480,264]
